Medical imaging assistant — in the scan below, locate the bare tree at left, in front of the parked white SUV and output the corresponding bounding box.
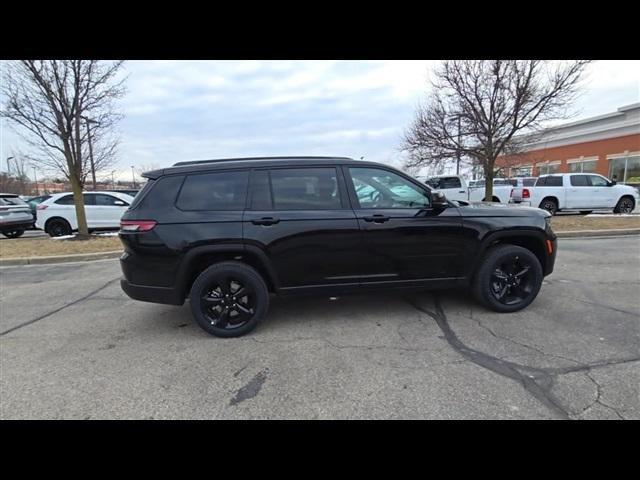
[1,60,124,237]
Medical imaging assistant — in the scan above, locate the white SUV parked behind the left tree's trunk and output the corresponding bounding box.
[36,191,133,237]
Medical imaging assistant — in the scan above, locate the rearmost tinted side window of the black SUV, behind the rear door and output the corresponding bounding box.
[176,171,249,210]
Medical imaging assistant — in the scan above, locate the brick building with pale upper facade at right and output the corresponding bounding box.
[496,103,640,184]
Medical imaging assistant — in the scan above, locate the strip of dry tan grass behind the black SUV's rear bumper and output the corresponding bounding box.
[0,237,123,258]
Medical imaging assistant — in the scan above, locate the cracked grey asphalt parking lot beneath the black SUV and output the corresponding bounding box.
[0,236,640,419]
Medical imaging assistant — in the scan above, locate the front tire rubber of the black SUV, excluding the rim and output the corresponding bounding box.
[473,244,544,313]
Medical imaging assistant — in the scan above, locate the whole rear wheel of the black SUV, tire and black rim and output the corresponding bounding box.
[189,261,269,337]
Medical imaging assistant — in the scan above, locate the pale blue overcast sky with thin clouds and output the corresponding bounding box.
[0,61,640,179]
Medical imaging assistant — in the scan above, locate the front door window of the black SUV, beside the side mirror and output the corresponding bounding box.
[349,168,429,208]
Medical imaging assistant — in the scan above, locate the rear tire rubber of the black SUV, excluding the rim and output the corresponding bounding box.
[189,262,269,338]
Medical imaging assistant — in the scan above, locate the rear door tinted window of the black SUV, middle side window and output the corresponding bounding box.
[270,168,342,210]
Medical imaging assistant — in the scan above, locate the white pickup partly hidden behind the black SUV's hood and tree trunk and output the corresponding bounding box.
[416,175,513,203]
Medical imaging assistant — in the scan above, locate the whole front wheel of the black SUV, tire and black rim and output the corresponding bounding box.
[472,244,544,313]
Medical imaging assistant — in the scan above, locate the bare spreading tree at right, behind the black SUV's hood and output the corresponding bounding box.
[402,60,589,200]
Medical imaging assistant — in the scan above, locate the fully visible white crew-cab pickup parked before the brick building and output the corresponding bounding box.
[511,173,640,215]
